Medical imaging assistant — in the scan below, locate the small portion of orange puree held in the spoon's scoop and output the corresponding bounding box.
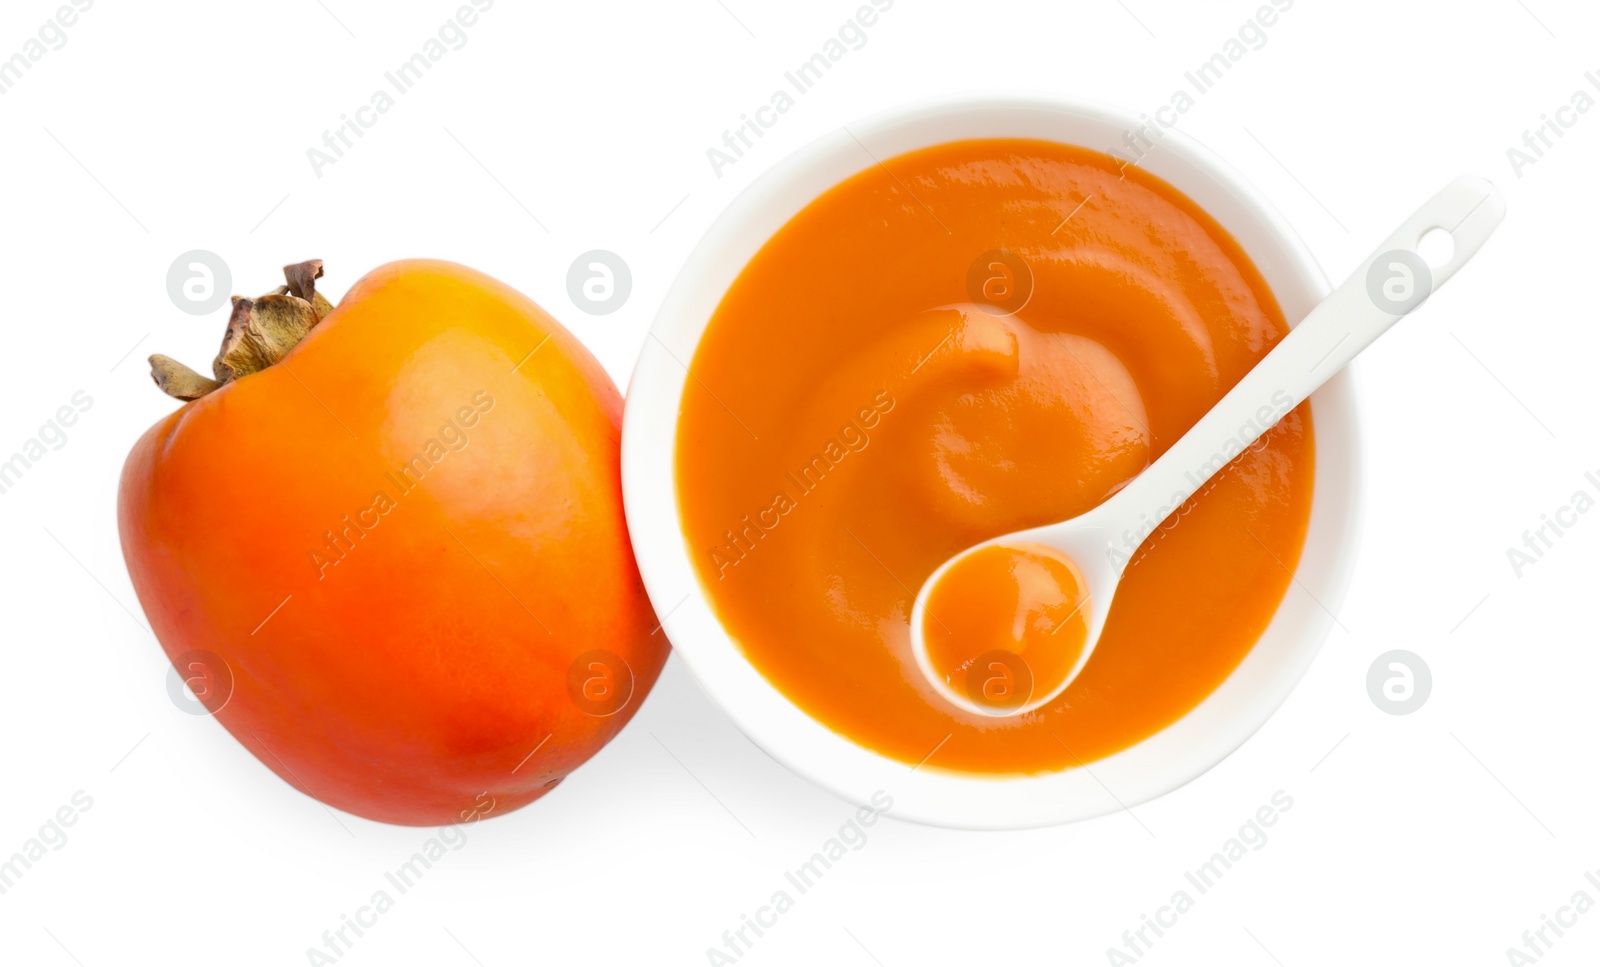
[922,544,1088,714]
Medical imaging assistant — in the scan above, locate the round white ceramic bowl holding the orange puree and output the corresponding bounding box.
[622,96,1360,829]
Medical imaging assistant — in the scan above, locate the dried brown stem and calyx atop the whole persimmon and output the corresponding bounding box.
[150,259,333,400]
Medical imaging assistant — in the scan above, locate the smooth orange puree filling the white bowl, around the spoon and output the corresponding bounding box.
[675,139,1314,775]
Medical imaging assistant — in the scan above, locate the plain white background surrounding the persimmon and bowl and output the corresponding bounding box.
[0,0,1600,967]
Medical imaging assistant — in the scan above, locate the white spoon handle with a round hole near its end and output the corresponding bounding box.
[1101,178,1506,568]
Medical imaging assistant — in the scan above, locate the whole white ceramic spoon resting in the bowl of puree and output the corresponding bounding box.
[910,178,1506,716]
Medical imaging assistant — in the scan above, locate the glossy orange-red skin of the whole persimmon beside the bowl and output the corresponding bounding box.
[118,261,667,826]
